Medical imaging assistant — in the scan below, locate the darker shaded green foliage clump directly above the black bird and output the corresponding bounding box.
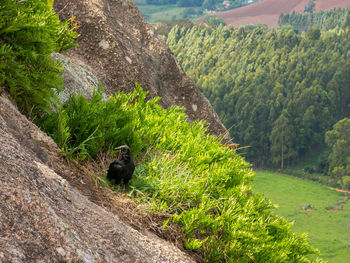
[40,86,150,161]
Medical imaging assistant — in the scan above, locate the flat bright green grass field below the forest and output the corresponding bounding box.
[254,172,350,263]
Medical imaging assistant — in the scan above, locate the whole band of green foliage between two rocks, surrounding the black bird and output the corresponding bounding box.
[42,85,317,262]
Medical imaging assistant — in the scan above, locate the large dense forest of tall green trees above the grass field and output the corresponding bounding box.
[166,20,350,171]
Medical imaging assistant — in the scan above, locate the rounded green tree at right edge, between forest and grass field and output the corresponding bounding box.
[326,118,350,179]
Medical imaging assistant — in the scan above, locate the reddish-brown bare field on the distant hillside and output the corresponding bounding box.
[196,0,350,28]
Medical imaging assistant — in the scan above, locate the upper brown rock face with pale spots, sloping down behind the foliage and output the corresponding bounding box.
[54,0,226,139]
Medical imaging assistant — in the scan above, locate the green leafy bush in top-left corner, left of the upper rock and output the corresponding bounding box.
[0,0,77,116]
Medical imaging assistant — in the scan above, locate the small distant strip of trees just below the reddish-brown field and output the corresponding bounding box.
[278,8,350,32]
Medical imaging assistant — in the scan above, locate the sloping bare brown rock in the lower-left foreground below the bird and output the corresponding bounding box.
[0,94,194,263]
